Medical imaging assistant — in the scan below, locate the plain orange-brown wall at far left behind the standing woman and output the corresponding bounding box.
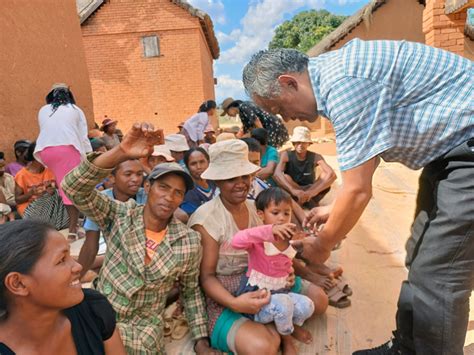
[0,0,93,160]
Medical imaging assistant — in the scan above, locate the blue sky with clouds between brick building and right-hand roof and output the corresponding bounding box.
[188,0,369,104]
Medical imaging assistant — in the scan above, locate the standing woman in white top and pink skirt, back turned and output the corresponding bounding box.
[34,84,92,240]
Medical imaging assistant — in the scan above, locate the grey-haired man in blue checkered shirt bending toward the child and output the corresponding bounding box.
[243,39,474,354]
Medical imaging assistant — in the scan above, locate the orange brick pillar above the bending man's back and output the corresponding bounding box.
[423,0,469,56]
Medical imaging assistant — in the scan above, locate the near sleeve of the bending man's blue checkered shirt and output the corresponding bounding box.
[326,77,393,171]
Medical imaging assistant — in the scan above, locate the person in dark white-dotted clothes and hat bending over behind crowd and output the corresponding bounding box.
[221,97,289,148]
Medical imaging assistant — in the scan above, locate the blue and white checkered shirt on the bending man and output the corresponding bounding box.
[308,39,474,170]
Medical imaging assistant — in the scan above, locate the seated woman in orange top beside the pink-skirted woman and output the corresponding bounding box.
[15,143,69,232]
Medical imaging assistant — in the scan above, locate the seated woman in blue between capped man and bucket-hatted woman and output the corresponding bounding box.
[175,147,219,223]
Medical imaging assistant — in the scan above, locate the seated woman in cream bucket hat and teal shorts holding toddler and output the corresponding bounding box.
[188,139,327,354]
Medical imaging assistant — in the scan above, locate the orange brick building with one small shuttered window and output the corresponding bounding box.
[77,0,219,133]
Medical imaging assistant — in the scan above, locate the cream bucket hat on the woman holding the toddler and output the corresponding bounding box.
[201,139,260,180]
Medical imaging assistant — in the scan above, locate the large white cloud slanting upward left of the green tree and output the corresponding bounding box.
[220,0,326,64]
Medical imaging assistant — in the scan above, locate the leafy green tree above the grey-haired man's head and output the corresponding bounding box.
[268,10,347,52]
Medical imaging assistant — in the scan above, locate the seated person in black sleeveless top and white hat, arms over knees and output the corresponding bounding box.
[273,126,336,207]
